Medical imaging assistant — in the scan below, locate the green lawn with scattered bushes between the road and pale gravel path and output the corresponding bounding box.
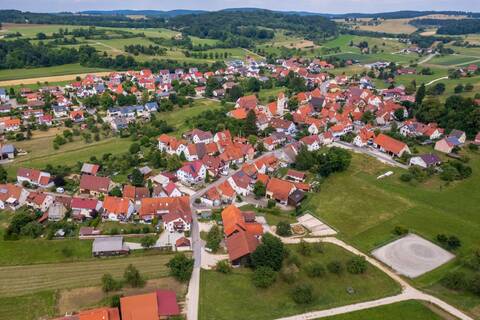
[199,244,400,320]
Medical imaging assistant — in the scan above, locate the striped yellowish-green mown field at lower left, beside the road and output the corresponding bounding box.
[0,250,172,297]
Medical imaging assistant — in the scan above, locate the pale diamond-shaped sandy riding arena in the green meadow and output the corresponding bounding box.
[372,234,455,278]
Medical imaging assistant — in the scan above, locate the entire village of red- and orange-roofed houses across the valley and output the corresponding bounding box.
[0,53,480,320]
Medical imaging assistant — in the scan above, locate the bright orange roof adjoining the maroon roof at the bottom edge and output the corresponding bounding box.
[120,292,158,320]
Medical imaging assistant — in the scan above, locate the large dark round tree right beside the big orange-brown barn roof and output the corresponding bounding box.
[251,233,286,271]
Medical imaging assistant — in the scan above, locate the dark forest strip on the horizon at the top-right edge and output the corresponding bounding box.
[410,19,480,35]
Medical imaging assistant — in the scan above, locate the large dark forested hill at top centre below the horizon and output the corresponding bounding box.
[166,10,337,47]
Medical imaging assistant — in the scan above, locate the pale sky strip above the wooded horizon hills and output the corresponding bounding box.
[0,0,480,13]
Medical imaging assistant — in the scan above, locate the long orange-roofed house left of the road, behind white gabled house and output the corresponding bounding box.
[139,196,192,222]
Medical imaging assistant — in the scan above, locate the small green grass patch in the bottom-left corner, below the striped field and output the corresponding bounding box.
[0,290,56,320]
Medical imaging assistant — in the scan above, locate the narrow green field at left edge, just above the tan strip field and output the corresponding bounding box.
[0,63,108,81]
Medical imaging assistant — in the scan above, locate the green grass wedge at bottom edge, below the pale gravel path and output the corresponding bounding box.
[322,300,443,320]
